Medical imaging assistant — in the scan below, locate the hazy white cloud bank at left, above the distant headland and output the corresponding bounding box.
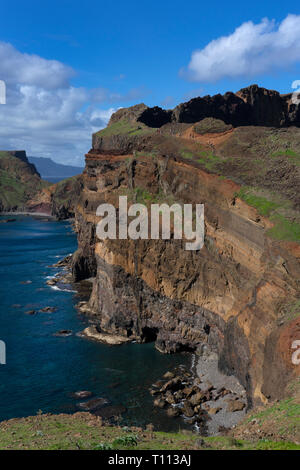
[0,42,140,165]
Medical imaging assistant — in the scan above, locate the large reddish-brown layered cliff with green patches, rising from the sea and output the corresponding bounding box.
[73,87,300,404]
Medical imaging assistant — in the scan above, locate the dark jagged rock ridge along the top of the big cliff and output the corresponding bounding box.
[104,85,300,127]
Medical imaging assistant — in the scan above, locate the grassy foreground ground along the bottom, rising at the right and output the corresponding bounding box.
[0,402,300,450]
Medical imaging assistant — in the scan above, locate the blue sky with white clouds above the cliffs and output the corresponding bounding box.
[0,0,300,164]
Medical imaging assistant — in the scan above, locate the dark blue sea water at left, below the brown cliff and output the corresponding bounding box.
[0,216,191,430]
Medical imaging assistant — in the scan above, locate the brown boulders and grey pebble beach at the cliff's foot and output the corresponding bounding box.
[150,351,247,436]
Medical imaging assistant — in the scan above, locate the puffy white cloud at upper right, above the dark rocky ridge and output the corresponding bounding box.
[182,15,300,82]
